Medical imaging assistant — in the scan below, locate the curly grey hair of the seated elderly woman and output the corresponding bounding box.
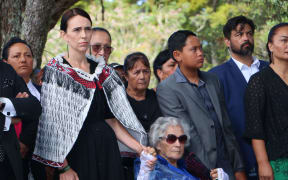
[149,117,190,148]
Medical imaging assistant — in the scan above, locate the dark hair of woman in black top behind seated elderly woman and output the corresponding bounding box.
[123,52,150,74]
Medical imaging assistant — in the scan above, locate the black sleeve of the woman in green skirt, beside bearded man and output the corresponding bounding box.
[244,74,266,140]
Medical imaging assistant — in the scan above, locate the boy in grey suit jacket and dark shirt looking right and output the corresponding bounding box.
[156,30,245,180]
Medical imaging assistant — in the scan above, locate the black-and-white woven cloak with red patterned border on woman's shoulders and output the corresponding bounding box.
[33,55,147,167]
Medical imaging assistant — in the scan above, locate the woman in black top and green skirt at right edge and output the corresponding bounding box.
[245,23,288,179]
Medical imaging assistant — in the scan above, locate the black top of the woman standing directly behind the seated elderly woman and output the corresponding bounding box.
[127,89,162,132]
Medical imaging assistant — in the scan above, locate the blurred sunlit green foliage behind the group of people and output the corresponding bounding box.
[42,0,288,87]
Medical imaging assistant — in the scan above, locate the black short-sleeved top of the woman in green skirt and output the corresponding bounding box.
[244,66,288,161]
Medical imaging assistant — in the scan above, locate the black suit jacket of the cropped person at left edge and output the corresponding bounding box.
[0,61,41,180]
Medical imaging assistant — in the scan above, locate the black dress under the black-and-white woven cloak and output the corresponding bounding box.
[67,59,124,180]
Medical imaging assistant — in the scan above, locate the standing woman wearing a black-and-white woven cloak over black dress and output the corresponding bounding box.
[33,8,143,180]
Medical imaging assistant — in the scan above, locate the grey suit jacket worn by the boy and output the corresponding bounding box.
[156,69,244,179]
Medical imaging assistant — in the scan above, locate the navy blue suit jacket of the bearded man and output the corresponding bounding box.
[209,58,268,170]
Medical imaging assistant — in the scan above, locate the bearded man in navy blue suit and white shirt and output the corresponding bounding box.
[210,16,268,179]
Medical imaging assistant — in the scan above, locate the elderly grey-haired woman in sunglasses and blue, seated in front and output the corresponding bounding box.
[135,117,229,180]
